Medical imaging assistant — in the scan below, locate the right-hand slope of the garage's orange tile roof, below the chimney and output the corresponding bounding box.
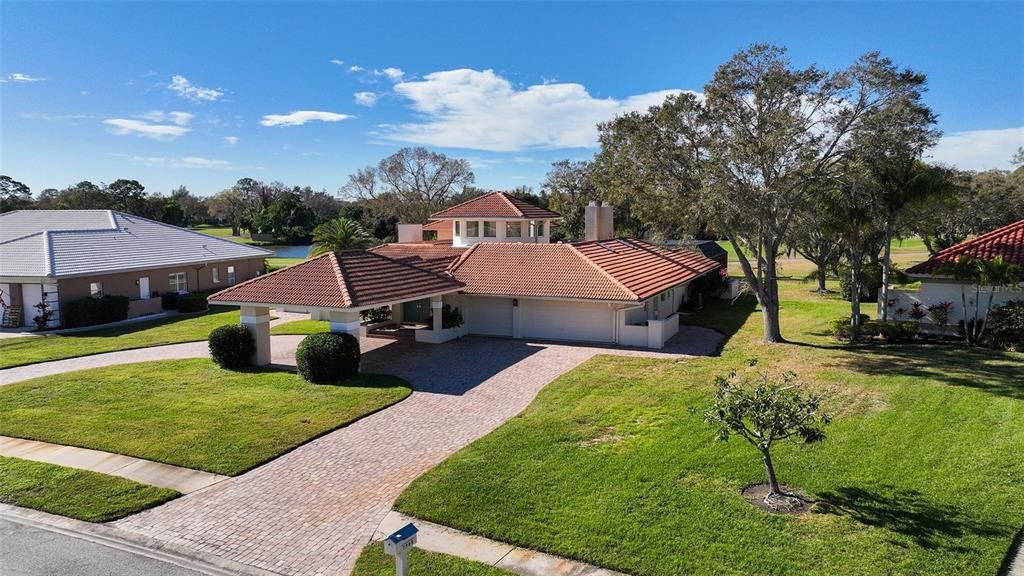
[572,239,721,300]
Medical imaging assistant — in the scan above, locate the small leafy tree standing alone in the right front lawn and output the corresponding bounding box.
[705,370,830,509]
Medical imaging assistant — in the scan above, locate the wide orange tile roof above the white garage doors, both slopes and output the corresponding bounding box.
[449,240,721,301]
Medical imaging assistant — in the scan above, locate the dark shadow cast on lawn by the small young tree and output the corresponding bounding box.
[814,486,1013,551]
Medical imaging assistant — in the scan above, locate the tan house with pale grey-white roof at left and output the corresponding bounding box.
[0,210,272,326]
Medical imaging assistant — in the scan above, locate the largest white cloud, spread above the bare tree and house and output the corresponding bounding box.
[382,69,682,152]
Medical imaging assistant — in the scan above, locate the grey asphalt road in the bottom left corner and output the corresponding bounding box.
[0,518,202,576]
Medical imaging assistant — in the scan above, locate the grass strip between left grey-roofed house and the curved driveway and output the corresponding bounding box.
[0,308,239,368]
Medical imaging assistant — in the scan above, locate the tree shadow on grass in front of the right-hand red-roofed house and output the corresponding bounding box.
[823,344,1024,400]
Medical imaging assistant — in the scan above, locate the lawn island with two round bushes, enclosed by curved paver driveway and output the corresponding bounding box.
[0,360,411,475]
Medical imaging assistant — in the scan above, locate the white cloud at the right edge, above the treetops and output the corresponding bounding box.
[925,126,1024,170]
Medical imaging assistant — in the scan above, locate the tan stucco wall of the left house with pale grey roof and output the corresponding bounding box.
[57,258,263,306]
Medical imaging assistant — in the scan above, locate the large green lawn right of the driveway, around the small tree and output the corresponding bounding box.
[396,282,1024,576]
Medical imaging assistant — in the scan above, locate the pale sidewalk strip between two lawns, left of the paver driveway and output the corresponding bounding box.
[0,436,228,494]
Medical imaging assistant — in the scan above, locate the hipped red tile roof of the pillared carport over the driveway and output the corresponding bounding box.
[210,250,463,308]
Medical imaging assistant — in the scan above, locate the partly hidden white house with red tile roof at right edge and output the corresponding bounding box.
[878,220,1024,330]
